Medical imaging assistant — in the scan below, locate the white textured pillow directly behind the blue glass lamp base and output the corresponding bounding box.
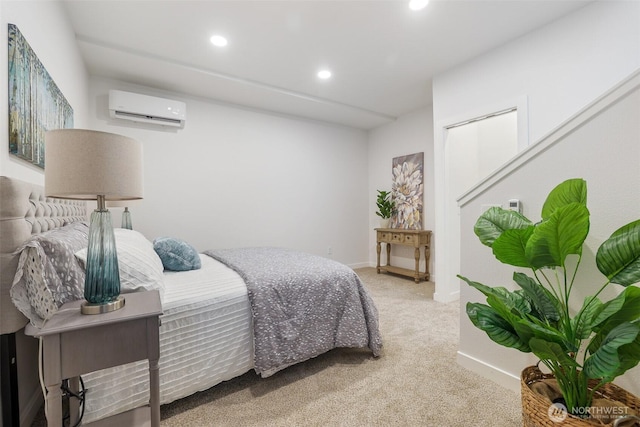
[75,228,164,297]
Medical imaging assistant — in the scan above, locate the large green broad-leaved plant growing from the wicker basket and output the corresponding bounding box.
[458,179,640,416]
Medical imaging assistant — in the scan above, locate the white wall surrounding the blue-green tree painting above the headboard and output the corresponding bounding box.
[0,0,88,185]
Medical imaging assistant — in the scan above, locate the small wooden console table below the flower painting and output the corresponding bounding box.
[375,228,431,283]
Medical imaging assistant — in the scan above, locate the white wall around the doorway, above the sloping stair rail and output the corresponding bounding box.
[433,0,640,300]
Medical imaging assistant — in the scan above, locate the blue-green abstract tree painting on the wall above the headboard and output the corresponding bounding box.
[9,24,73,169]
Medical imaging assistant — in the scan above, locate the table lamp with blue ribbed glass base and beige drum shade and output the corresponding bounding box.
[44,129,143,314]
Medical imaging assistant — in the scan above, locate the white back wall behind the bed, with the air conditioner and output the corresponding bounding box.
[90,78,369,266]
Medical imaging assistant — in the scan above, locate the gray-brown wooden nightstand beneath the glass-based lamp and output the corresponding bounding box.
[25,291,162,427]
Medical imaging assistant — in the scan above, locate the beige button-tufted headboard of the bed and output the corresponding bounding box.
[0,176,87,334]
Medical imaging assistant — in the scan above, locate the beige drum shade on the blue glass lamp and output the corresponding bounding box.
[44,129,143,200]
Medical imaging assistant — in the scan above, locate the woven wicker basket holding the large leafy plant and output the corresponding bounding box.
[520,366,640,427]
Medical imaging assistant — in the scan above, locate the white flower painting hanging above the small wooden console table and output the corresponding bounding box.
[391,153,424,230]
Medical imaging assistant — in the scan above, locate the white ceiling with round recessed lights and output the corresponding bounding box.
[64,0,588,129]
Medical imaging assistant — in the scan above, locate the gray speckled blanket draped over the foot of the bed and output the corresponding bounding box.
[204,247,382,377]
